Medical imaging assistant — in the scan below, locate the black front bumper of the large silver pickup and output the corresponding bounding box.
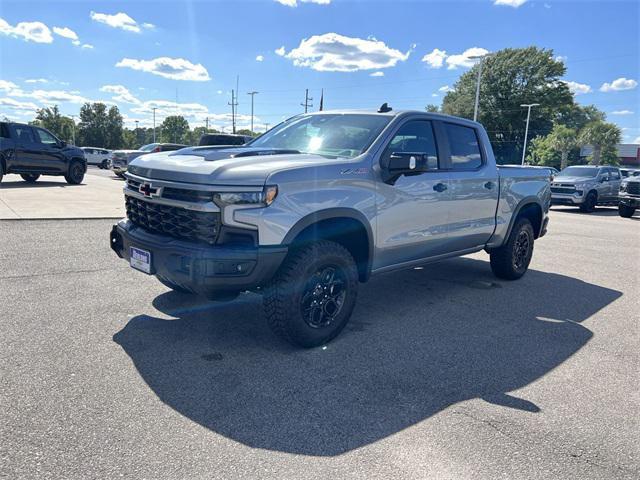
[110,220,288,298]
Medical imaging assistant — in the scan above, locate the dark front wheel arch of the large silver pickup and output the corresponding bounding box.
[282,208,374,282]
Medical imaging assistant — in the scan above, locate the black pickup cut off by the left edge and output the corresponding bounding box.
[0,122,87,185]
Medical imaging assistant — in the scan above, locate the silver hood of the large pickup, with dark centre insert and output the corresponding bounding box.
[129,147,345,185]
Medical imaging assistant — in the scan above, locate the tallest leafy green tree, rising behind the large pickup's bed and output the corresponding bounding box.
[442,47,573,163]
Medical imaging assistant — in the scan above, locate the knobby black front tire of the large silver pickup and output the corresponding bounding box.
[263,240,358,348]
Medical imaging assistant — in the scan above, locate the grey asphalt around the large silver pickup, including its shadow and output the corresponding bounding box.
[0,209,640,479]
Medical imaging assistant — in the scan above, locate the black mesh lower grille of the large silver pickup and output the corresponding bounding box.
[125,195,220,245]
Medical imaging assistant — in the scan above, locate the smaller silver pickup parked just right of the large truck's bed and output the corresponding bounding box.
[551,165,621,213]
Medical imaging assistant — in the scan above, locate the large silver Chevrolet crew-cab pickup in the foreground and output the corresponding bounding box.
[110,108,551,347]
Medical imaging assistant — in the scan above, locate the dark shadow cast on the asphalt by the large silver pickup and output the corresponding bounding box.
[113,258,622,456]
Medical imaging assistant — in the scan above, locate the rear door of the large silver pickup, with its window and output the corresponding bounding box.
[439,122,500,252]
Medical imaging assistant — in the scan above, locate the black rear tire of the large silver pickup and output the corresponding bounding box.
[490,218,535,280]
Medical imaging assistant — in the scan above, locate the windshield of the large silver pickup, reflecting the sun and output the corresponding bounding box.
[249,114,392,158]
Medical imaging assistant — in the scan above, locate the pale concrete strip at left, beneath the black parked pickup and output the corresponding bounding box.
[0,166,124,220]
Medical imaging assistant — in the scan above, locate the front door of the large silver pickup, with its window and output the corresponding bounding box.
[374,120,450,269]
